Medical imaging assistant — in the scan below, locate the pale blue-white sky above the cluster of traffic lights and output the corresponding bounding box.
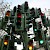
[4,0,50,10]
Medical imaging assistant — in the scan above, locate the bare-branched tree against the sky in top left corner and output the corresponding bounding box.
[0,0,10,17]
